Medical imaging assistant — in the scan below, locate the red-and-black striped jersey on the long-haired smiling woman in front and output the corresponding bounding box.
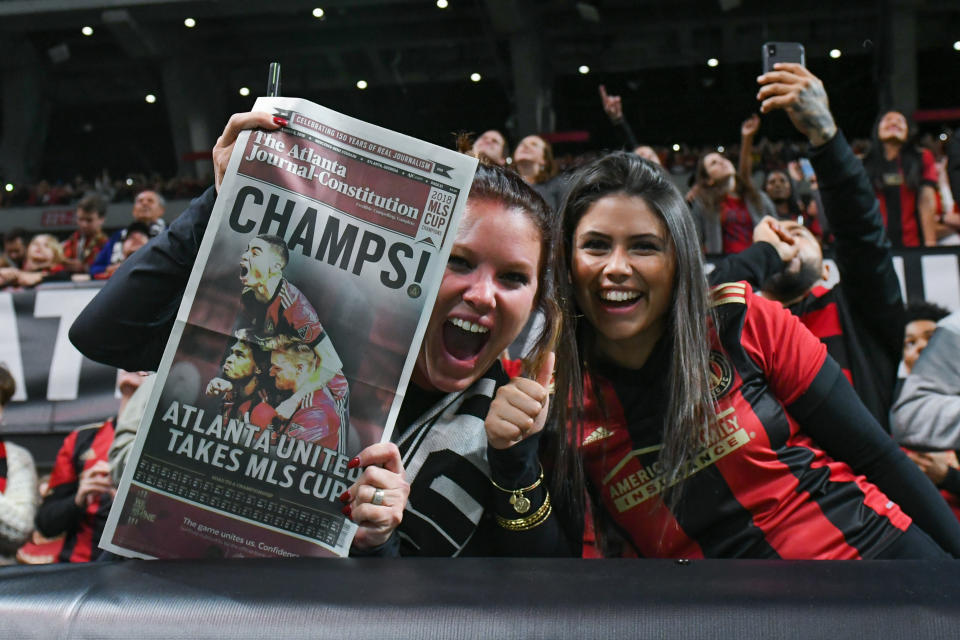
[580,283,911,559]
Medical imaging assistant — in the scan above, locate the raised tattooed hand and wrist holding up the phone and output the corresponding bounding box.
[757,62,837,147]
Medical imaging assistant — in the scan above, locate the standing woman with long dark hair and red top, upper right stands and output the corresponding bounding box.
[863,111,939,247]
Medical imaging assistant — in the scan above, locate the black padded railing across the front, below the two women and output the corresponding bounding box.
[0,558,960,640]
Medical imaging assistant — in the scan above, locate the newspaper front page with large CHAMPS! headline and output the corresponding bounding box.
[101,98,476,558]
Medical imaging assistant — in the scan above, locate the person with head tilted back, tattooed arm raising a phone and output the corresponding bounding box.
[700,63,904,430]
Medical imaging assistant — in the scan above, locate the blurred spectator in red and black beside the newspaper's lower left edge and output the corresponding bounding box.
[36,371,142,562]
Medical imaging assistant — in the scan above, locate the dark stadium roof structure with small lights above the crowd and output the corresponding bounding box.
[0,0,960,180]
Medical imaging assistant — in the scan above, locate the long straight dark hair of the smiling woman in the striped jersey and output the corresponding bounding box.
[554,152,714,552]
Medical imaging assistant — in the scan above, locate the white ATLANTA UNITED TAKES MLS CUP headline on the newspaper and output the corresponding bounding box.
[161,400,360,502]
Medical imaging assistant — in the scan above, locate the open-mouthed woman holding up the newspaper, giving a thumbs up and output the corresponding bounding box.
[70,113,569,555]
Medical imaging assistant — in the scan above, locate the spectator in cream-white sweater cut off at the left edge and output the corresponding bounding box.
[0,365,37,565]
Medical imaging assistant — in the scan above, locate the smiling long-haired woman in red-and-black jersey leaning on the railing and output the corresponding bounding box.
[491,153,960,559]
